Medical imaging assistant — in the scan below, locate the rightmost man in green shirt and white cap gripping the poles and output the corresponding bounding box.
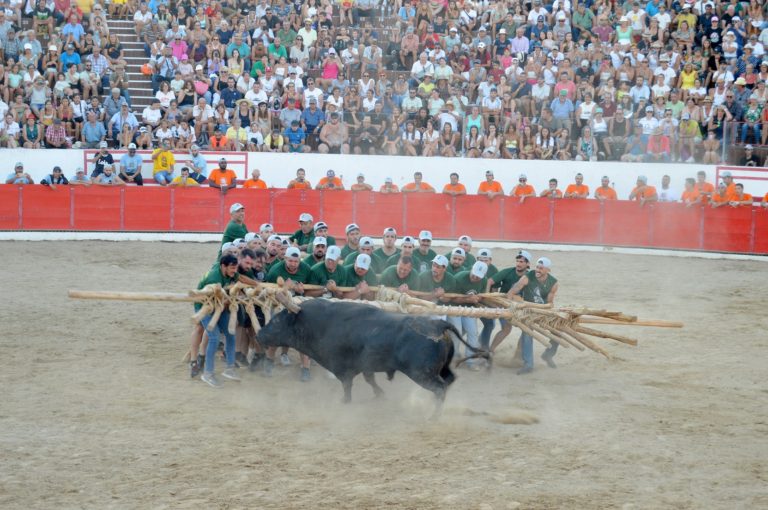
[509,257,560,375]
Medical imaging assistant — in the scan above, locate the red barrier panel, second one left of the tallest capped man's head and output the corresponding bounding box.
[123,186,171,232]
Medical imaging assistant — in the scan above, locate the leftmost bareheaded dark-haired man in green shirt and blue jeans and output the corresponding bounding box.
[190,253,240,388]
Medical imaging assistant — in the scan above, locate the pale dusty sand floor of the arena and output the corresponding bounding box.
[0,242,768,509]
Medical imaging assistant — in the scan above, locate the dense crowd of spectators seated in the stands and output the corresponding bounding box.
[0,0,768,163]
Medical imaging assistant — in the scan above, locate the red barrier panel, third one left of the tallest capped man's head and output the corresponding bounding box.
[72,186,121,230]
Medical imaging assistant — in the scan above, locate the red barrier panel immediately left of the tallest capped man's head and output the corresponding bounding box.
[171,187,225,232]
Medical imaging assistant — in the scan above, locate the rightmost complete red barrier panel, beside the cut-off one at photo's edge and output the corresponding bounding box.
[704,205,752,252]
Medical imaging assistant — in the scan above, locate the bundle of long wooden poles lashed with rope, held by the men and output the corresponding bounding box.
[69,282,683,358]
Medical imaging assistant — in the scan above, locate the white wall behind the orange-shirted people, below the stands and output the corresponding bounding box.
[7,149,768,198]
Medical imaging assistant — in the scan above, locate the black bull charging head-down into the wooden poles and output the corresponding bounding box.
[258,299,480,408]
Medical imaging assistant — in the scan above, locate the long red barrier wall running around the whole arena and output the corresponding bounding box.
[0,185,768,254]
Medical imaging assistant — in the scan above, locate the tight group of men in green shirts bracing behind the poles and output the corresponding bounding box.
[190,203,558,387]
